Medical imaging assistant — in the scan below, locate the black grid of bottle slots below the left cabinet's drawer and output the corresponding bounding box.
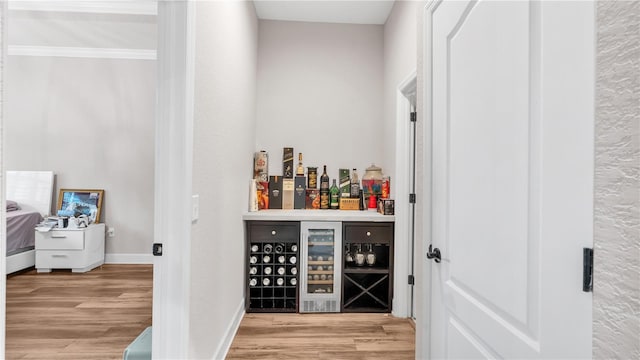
[247,221,299,312]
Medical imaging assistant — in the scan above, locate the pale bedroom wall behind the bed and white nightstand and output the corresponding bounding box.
[4,10,156,261]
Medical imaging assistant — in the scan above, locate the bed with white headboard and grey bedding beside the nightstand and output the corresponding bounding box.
[6,171,54,274]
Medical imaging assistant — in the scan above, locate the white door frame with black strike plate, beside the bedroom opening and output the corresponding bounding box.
[153,0,195,359]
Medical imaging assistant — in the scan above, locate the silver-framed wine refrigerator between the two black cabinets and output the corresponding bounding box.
[299,221,342,313]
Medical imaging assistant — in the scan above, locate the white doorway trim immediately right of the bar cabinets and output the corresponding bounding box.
[393,70,417,317]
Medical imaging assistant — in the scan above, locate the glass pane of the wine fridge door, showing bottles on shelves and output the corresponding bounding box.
[305,229,336,294]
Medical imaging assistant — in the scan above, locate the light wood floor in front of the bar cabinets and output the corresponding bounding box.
[227,313,415,360]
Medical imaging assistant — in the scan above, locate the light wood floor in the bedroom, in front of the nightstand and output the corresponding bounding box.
[6,265,153,360]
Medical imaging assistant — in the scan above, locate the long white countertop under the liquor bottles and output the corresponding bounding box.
[242,209,396,222]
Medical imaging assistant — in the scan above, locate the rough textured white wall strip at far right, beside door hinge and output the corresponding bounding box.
[593,1,640,359]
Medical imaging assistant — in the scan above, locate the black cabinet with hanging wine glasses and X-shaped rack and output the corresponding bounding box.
[342,222,393,312]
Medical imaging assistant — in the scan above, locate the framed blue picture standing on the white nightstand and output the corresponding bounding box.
[58,189,104,223]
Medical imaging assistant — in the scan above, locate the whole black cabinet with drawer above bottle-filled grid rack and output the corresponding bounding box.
[246,221,300,312]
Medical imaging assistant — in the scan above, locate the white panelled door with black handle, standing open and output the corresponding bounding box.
[425,1,594,359]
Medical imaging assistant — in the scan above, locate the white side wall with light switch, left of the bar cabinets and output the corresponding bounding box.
[189,1,258,359]
